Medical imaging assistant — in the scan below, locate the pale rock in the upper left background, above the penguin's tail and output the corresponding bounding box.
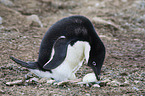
[27,15,43,27]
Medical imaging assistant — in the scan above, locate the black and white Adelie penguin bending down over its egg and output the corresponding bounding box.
[10,16,105,81]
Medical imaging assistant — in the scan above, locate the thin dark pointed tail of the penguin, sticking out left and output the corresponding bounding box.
[10,56,38,69]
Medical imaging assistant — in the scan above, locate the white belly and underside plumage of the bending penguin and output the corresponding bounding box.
[31,41,90,81]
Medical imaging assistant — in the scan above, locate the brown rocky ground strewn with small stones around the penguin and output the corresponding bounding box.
[0,0,145,96]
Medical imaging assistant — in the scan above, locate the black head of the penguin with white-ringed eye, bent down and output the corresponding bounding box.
[88,41,105,80]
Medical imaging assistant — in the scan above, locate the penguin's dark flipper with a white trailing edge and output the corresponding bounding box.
[43,36,71,70]
